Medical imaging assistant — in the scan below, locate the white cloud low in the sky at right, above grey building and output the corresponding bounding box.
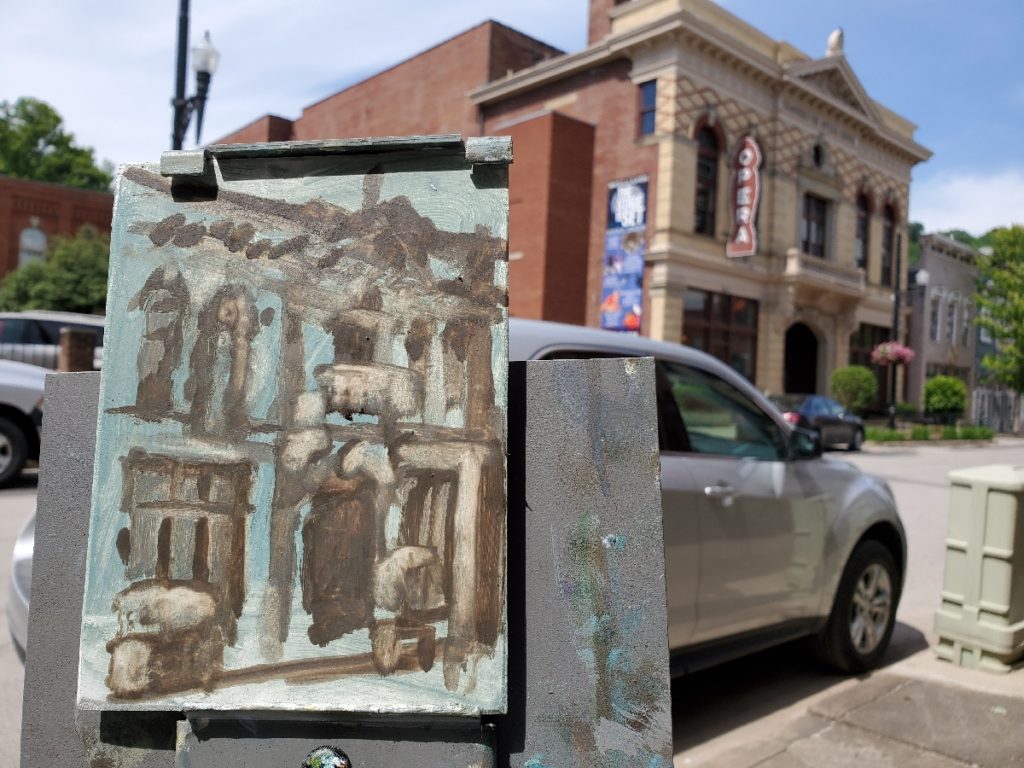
[910,168,1024,234]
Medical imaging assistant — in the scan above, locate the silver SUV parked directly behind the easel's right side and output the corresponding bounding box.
[509,319,906,674]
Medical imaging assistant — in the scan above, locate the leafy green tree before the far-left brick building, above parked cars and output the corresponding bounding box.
[0,224,111,313]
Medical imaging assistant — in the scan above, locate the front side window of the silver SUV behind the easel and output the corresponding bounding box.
[658,361,786,461]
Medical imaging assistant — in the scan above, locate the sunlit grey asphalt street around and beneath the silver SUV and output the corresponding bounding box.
[0,439,1024,766]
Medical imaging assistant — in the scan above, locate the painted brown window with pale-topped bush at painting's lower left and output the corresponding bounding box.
[106,449,253,699]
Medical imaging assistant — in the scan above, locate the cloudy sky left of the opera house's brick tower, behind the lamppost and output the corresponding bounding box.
[0,0,587,163]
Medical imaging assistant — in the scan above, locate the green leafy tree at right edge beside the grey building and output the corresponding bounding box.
[975,224,1024,393]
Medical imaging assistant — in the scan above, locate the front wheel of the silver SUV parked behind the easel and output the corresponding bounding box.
[816,541,899,673]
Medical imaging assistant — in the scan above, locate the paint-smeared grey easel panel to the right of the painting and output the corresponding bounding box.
[499,359,672,768]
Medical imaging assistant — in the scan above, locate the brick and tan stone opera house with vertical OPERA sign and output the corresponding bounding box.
[223,0,930,391]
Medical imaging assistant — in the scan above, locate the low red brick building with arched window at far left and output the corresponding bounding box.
[0,176,114,280]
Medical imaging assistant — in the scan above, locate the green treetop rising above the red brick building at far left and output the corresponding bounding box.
[0,98,111,191]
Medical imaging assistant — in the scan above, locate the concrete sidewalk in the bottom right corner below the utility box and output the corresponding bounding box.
[676,649,1024,768]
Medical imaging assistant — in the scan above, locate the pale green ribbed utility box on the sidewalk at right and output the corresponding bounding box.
[935,464,1024,673]
